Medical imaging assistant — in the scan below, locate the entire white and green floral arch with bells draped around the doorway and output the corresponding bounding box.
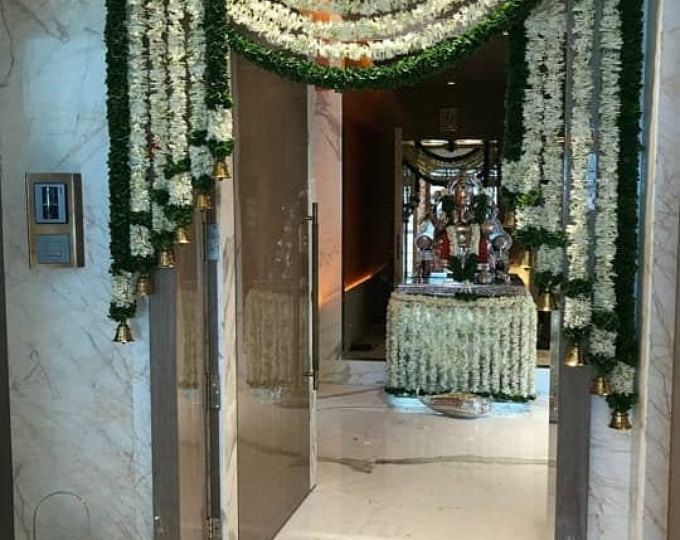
[105,0,643,426]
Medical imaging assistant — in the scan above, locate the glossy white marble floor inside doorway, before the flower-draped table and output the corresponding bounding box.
[277,370,554,540]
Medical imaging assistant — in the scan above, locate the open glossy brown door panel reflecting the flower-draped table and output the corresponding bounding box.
[234,58,310,540]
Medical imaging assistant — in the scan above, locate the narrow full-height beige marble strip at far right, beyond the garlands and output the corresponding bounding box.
[631,0,680,540]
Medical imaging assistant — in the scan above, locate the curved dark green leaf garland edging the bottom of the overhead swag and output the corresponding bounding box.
[226,0,538,90]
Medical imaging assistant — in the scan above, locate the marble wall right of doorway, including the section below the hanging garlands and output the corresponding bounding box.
[588,0,680,540]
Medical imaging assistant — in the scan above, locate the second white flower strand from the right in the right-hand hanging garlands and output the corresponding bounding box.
[564,0,595,330]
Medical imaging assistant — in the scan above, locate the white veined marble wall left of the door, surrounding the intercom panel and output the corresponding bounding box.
[0,0,152,540]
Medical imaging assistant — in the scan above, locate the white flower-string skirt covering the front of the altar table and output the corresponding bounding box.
[387,292,537,399]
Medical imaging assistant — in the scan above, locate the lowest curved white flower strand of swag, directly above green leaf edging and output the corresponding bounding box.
[228,0,504,61]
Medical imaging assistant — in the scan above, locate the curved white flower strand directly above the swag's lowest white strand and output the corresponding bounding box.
[231,0,463,41]
